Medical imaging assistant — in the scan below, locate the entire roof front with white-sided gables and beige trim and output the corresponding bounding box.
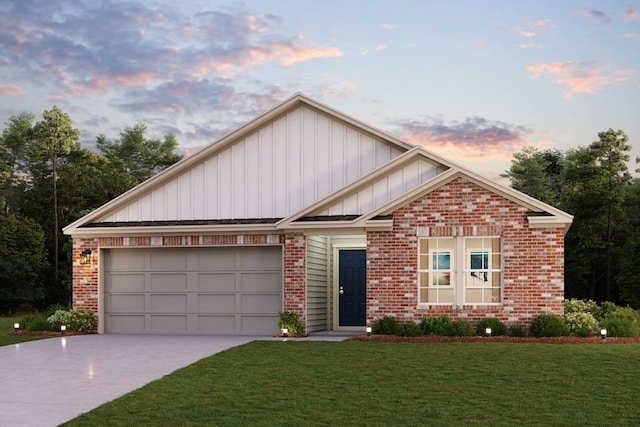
[64,93,573,236]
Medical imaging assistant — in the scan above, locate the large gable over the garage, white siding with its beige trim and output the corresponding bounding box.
[64,93,413,235]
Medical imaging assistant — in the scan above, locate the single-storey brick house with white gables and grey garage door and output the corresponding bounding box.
[64,94,572,335]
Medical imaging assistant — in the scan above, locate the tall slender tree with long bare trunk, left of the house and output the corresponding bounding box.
[31,106,80,282]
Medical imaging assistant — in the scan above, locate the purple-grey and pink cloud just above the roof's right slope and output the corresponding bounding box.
[395,116,532,161]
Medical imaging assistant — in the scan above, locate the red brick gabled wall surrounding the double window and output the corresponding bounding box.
[367,178,564,326]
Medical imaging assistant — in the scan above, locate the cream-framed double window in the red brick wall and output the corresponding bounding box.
[418,237,502,305]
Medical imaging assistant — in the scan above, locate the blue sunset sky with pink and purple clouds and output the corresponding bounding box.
[0,0,640,179]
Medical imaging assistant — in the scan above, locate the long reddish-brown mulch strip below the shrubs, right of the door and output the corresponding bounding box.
[349,335,640,344]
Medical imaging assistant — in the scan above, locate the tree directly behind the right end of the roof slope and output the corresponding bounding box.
[500,147,566,207]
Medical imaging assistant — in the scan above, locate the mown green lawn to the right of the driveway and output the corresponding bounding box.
[66,341,640,426]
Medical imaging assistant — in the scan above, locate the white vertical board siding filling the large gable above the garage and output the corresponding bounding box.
[96,105,404,222]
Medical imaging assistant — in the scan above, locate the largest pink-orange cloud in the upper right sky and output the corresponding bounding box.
[527,61,635,98]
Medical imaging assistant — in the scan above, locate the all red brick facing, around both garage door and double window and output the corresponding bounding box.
[73,178,564,332]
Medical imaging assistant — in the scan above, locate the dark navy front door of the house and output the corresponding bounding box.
[338,249,367,326]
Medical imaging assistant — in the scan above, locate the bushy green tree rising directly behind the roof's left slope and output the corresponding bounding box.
[97,124,182,190]
